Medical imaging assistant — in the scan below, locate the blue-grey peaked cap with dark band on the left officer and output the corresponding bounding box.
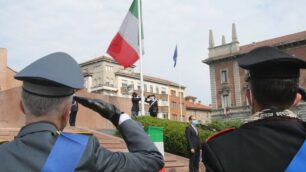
[15,52,84,97]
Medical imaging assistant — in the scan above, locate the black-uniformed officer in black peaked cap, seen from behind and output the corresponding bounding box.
[202,47,306,172]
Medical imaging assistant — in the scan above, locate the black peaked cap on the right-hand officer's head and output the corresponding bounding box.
[238,46,306,78]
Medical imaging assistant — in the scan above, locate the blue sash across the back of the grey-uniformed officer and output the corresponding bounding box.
[41,132,89,172]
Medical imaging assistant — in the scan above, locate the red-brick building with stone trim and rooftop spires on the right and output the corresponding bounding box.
[203,24,306,120]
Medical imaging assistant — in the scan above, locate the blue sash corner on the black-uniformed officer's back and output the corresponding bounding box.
[286,141,306,172]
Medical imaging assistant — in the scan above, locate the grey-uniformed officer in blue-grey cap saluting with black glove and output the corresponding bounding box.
[0,53,164,172]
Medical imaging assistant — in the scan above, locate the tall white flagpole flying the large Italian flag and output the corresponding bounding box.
[137,0,145,115]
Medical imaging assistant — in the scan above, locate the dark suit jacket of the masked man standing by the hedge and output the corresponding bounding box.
[185,125,201,152]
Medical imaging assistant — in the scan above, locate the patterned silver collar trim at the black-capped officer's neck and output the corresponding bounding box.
[249,109,298,121]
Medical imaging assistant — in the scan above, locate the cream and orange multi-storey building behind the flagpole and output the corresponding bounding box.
[80,56,186,121]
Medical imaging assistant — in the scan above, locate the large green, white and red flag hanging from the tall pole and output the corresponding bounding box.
[107,0,143,68]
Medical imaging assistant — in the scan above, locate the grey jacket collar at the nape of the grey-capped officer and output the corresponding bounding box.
[17,121,58,137]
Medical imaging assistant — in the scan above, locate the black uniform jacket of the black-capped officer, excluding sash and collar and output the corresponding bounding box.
[202,117,306,172]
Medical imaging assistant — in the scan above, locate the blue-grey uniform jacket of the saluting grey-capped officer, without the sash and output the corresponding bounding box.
[0,119,164,172]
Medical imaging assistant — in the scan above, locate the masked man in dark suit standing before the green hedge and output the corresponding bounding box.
[185,115,201,172]
